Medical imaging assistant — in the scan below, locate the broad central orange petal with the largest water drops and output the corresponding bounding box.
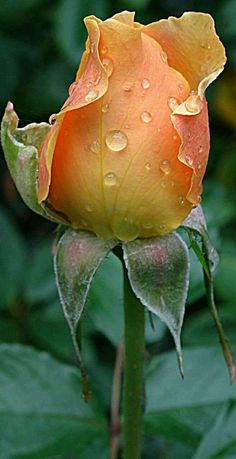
[46,13,193,240]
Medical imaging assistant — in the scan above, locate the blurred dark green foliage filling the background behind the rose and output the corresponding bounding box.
[0,0,236,459]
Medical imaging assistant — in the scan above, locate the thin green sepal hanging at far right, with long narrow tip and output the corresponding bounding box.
[182,206,236,383]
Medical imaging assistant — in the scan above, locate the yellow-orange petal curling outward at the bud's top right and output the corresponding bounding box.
[145,12,226,98]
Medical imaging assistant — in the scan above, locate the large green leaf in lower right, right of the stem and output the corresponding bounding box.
[145,346,236,459]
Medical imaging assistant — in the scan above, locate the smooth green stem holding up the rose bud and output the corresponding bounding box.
[123,266,145,459]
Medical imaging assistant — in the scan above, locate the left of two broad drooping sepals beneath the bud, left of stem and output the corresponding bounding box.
[54,229,117,400]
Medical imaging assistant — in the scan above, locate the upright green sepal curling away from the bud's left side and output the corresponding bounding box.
[1,102,62,222]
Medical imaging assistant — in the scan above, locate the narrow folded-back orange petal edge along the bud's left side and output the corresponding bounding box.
[38,16,108,202]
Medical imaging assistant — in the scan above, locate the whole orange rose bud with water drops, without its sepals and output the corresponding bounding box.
[38,11,226,241]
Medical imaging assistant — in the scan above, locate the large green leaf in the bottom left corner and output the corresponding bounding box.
[0,345,107,459]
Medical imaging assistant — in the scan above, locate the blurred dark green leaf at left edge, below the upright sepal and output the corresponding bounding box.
[0,208,26,309]
